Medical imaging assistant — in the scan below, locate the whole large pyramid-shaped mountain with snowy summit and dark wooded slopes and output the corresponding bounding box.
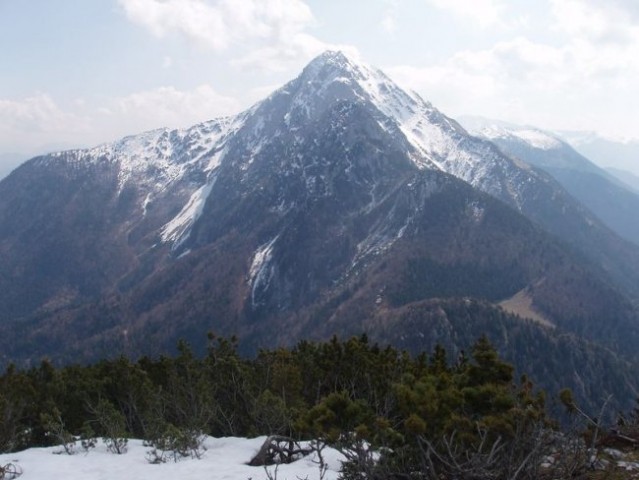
[0,52,639,412]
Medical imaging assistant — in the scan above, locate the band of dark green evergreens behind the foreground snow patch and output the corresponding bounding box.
[0,335,624,478]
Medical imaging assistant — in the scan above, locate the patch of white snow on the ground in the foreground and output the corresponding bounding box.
[0,437,343,480]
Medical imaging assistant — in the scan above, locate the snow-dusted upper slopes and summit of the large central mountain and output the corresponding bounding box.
[20,51,592,255]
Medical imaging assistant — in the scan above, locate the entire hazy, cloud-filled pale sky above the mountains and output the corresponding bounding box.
[0,0,639,161]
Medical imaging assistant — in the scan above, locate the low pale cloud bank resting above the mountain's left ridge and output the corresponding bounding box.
[0,85,248,154]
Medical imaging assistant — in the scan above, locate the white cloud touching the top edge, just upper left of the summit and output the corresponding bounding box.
[119,0,331,70]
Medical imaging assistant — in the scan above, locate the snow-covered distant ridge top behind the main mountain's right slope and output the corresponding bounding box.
[459,117,565,150]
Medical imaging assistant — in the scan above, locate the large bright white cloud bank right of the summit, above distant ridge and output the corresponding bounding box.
[388,27,639,137]
